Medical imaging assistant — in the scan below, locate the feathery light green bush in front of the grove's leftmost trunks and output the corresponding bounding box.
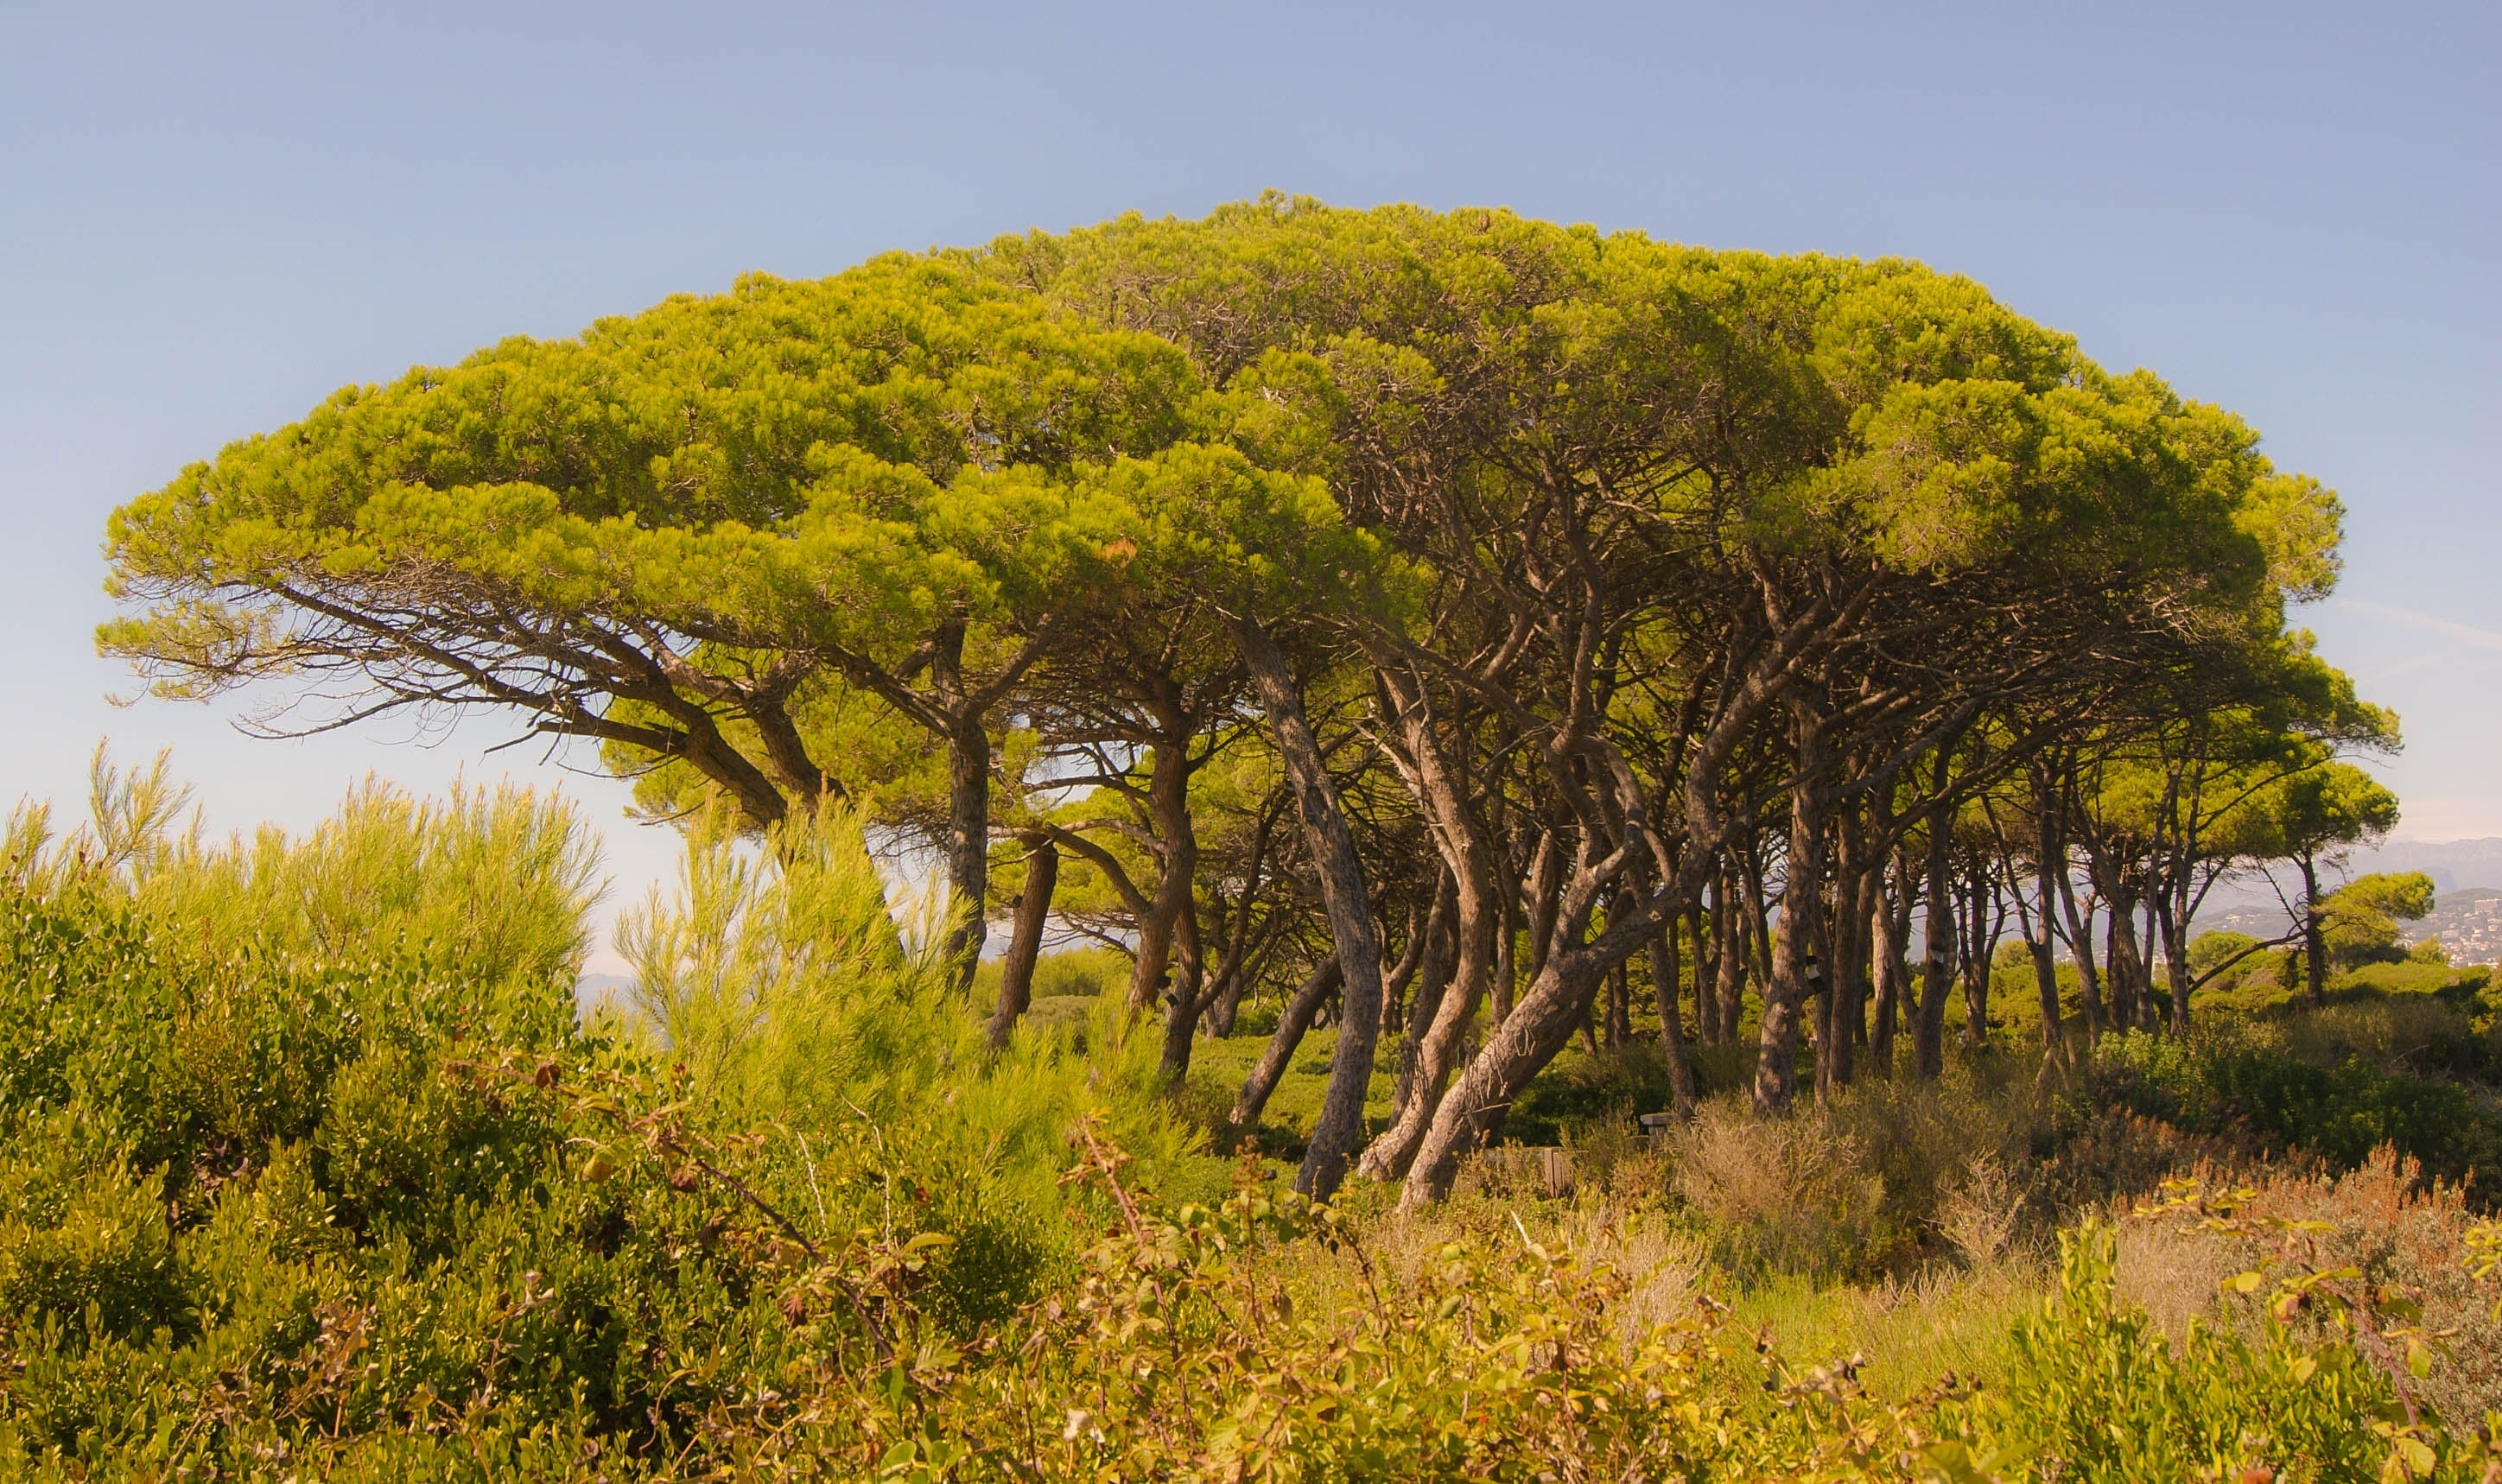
[618,809,1189,1319]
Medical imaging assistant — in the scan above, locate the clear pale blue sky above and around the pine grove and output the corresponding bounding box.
[0,0,2502,966]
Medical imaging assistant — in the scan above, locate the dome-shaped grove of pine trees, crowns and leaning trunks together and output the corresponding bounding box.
[103,198,2397,1204]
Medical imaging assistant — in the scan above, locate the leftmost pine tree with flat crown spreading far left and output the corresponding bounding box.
[103,257,1216,968]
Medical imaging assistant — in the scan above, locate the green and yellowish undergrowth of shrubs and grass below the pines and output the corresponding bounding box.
[0,771,2502,1481]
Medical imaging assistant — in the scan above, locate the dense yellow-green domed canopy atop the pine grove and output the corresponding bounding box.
[100,198,2340,855]
